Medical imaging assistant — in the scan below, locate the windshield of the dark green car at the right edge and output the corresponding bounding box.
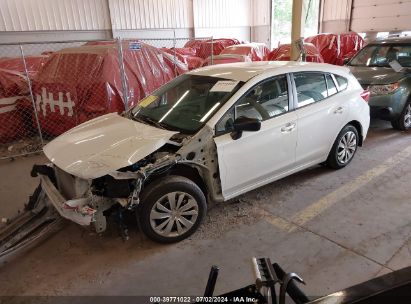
[349,44,411,67]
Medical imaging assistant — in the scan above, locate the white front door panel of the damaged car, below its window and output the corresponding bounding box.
[214,112,297,199]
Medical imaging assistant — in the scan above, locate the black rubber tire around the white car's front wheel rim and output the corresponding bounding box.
[137,175,207,243]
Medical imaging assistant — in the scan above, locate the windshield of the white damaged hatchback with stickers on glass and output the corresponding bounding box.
[131,74,244,134]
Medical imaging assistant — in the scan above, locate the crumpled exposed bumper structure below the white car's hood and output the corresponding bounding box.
[37,153,182,233]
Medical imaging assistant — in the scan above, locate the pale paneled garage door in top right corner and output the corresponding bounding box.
[351,0,411,32]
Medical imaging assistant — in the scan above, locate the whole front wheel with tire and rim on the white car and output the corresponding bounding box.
[137,175,207,243]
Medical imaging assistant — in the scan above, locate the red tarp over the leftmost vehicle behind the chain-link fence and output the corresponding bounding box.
[0,56,47,143]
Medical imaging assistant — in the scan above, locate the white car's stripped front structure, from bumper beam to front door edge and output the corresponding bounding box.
[38,123,222,233]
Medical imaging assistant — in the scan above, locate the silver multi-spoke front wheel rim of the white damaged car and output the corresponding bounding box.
[150,192,199,237]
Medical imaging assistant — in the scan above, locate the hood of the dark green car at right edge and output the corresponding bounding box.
[347,66,407,84]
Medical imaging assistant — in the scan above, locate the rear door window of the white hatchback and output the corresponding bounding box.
[294,73,328,107]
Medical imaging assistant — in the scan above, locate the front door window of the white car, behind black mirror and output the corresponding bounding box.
[216,75,289,135]
